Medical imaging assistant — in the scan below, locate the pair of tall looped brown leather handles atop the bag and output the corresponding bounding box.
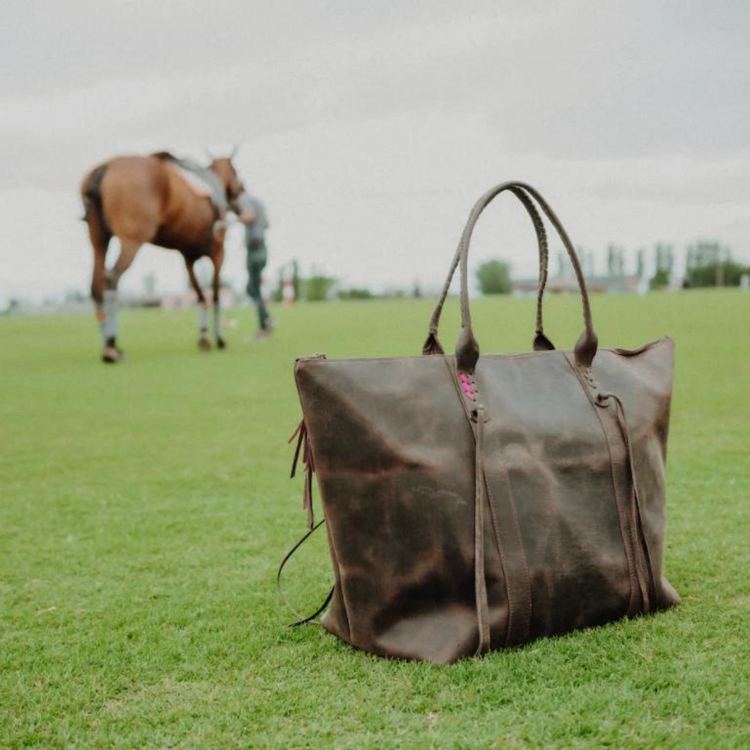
[423,181,598,373]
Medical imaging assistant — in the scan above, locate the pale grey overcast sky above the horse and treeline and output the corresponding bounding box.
[0,0,750,298]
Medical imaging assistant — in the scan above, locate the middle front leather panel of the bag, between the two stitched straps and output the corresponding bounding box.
[477,352,631,637]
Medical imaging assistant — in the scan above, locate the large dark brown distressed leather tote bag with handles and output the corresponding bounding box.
[282,182,679,663]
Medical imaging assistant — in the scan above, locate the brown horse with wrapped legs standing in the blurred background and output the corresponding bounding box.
[81,149,244,362]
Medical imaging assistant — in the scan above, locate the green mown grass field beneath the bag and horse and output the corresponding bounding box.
[0,292,750,750]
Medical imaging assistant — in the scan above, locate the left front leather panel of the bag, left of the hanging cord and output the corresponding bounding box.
[297,357,506,662]
